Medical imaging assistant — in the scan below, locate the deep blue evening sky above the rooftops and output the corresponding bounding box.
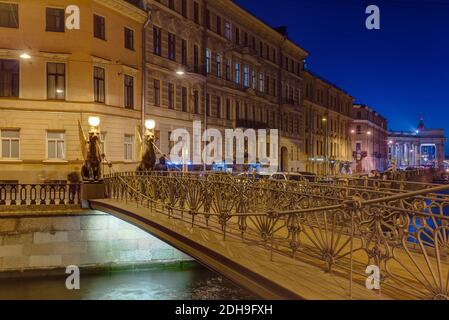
[236,0,449,153]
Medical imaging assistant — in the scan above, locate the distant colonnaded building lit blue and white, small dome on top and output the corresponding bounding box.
[388,118,447,168]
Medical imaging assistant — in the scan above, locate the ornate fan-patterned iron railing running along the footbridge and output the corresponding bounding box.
[105,173,449,299]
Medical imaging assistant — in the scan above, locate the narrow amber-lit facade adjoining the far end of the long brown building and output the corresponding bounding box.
[303,72,353,174]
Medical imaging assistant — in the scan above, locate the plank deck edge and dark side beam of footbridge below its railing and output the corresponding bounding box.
[90,199,390,300]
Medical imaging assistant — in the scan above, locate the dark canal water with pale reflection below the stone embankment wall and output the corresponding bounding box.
[0,265,255,300]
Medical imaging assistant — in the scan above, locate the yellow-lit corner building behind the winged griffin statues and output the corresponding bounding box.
[0,0,146,183]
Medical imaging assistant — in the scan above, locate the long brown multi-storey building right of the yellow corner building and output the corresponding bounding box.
[146,0,307,171]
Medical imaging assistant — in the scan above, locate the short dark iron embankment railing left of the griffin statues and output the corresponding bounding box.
[0,183,81,210]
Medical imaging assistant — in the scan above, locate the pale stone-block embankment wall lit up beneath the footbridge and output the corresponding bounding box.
[0,211,192,273]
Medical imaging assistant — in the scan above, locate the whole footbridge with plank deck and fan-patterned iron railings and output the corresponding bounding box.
[90,173,449,299]
